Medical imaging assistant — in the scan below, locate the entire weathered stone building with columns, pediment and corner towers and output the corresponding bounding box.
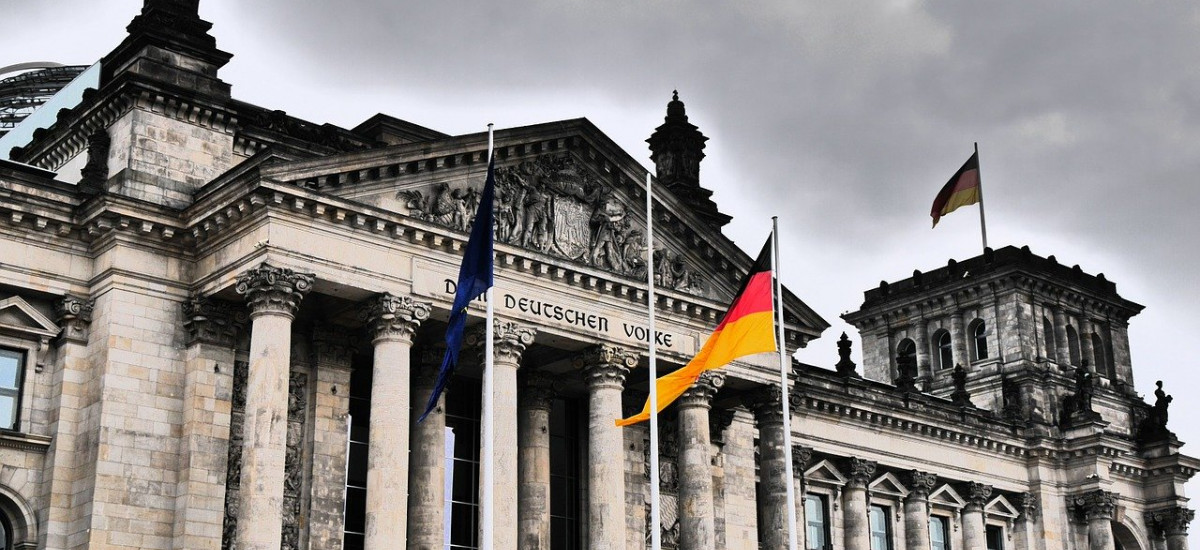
[0,0,1200,550]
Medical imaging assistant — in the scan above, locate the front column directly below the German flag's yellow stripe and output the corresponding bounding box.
[676,371,725,550]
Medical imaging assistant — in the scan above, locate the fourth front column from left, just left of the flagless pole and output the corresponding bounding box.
[581,343,637,550]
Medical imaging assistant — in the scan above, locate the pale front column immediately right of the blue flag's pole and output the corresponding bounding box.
[480,321,538,549]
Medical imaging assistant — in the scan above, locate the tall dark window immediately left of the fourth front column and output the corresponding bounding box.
[550,399,586,550]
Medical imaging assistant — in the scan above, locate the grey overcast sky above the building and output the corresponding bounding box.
[0,0,1200,544]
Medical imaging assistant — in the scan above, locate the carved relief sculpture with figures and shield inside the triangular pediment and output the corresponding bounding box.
[397,155,704,294]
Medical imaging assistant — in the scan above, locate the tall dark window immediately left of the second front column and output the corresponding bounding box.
[342,355,372,550]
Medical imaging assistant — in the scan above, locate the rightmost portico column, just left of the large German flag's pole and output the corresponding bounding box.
[745,385,800,550]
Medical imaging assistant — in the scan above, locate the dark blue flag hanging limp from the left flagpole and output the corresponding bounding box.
[416,154,496,422]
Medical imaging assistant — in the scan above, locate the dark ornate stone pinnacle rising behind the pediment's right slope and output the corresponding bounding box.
[646,91,731,227]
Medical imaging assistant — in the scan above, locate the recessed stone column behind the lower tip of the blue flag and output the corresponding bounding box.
[408,345,446,550]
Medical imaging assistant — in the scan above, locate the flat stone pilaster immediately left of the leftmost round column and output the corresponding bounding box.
[173,297,246,550]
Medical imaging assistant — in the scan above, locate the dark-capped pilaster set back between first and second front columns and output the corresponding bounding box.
[308,325,354,548]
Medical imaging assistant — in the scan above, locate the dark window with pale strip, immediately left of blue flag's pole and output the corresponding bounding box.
[445,379,482,550]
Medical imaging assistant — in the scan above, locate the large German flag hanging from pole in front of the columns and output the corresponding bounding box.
[617,239,776,426]
